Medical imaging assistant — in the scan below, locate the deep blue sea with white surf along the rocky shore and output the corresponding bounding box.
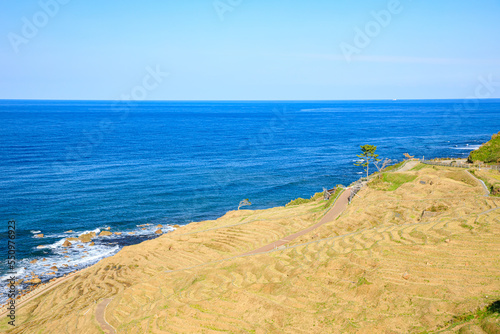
[0,100,500,300]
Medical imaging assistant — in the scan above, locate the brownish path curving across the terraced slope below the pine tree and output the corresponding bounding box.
[243,188,351,255]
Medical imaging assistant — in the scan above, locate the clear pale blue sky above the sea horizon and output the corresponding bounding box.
[0,0,500,100]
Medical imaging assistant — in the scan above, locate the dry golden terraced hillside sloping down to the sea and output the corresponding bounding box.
[0,165,500,333]
